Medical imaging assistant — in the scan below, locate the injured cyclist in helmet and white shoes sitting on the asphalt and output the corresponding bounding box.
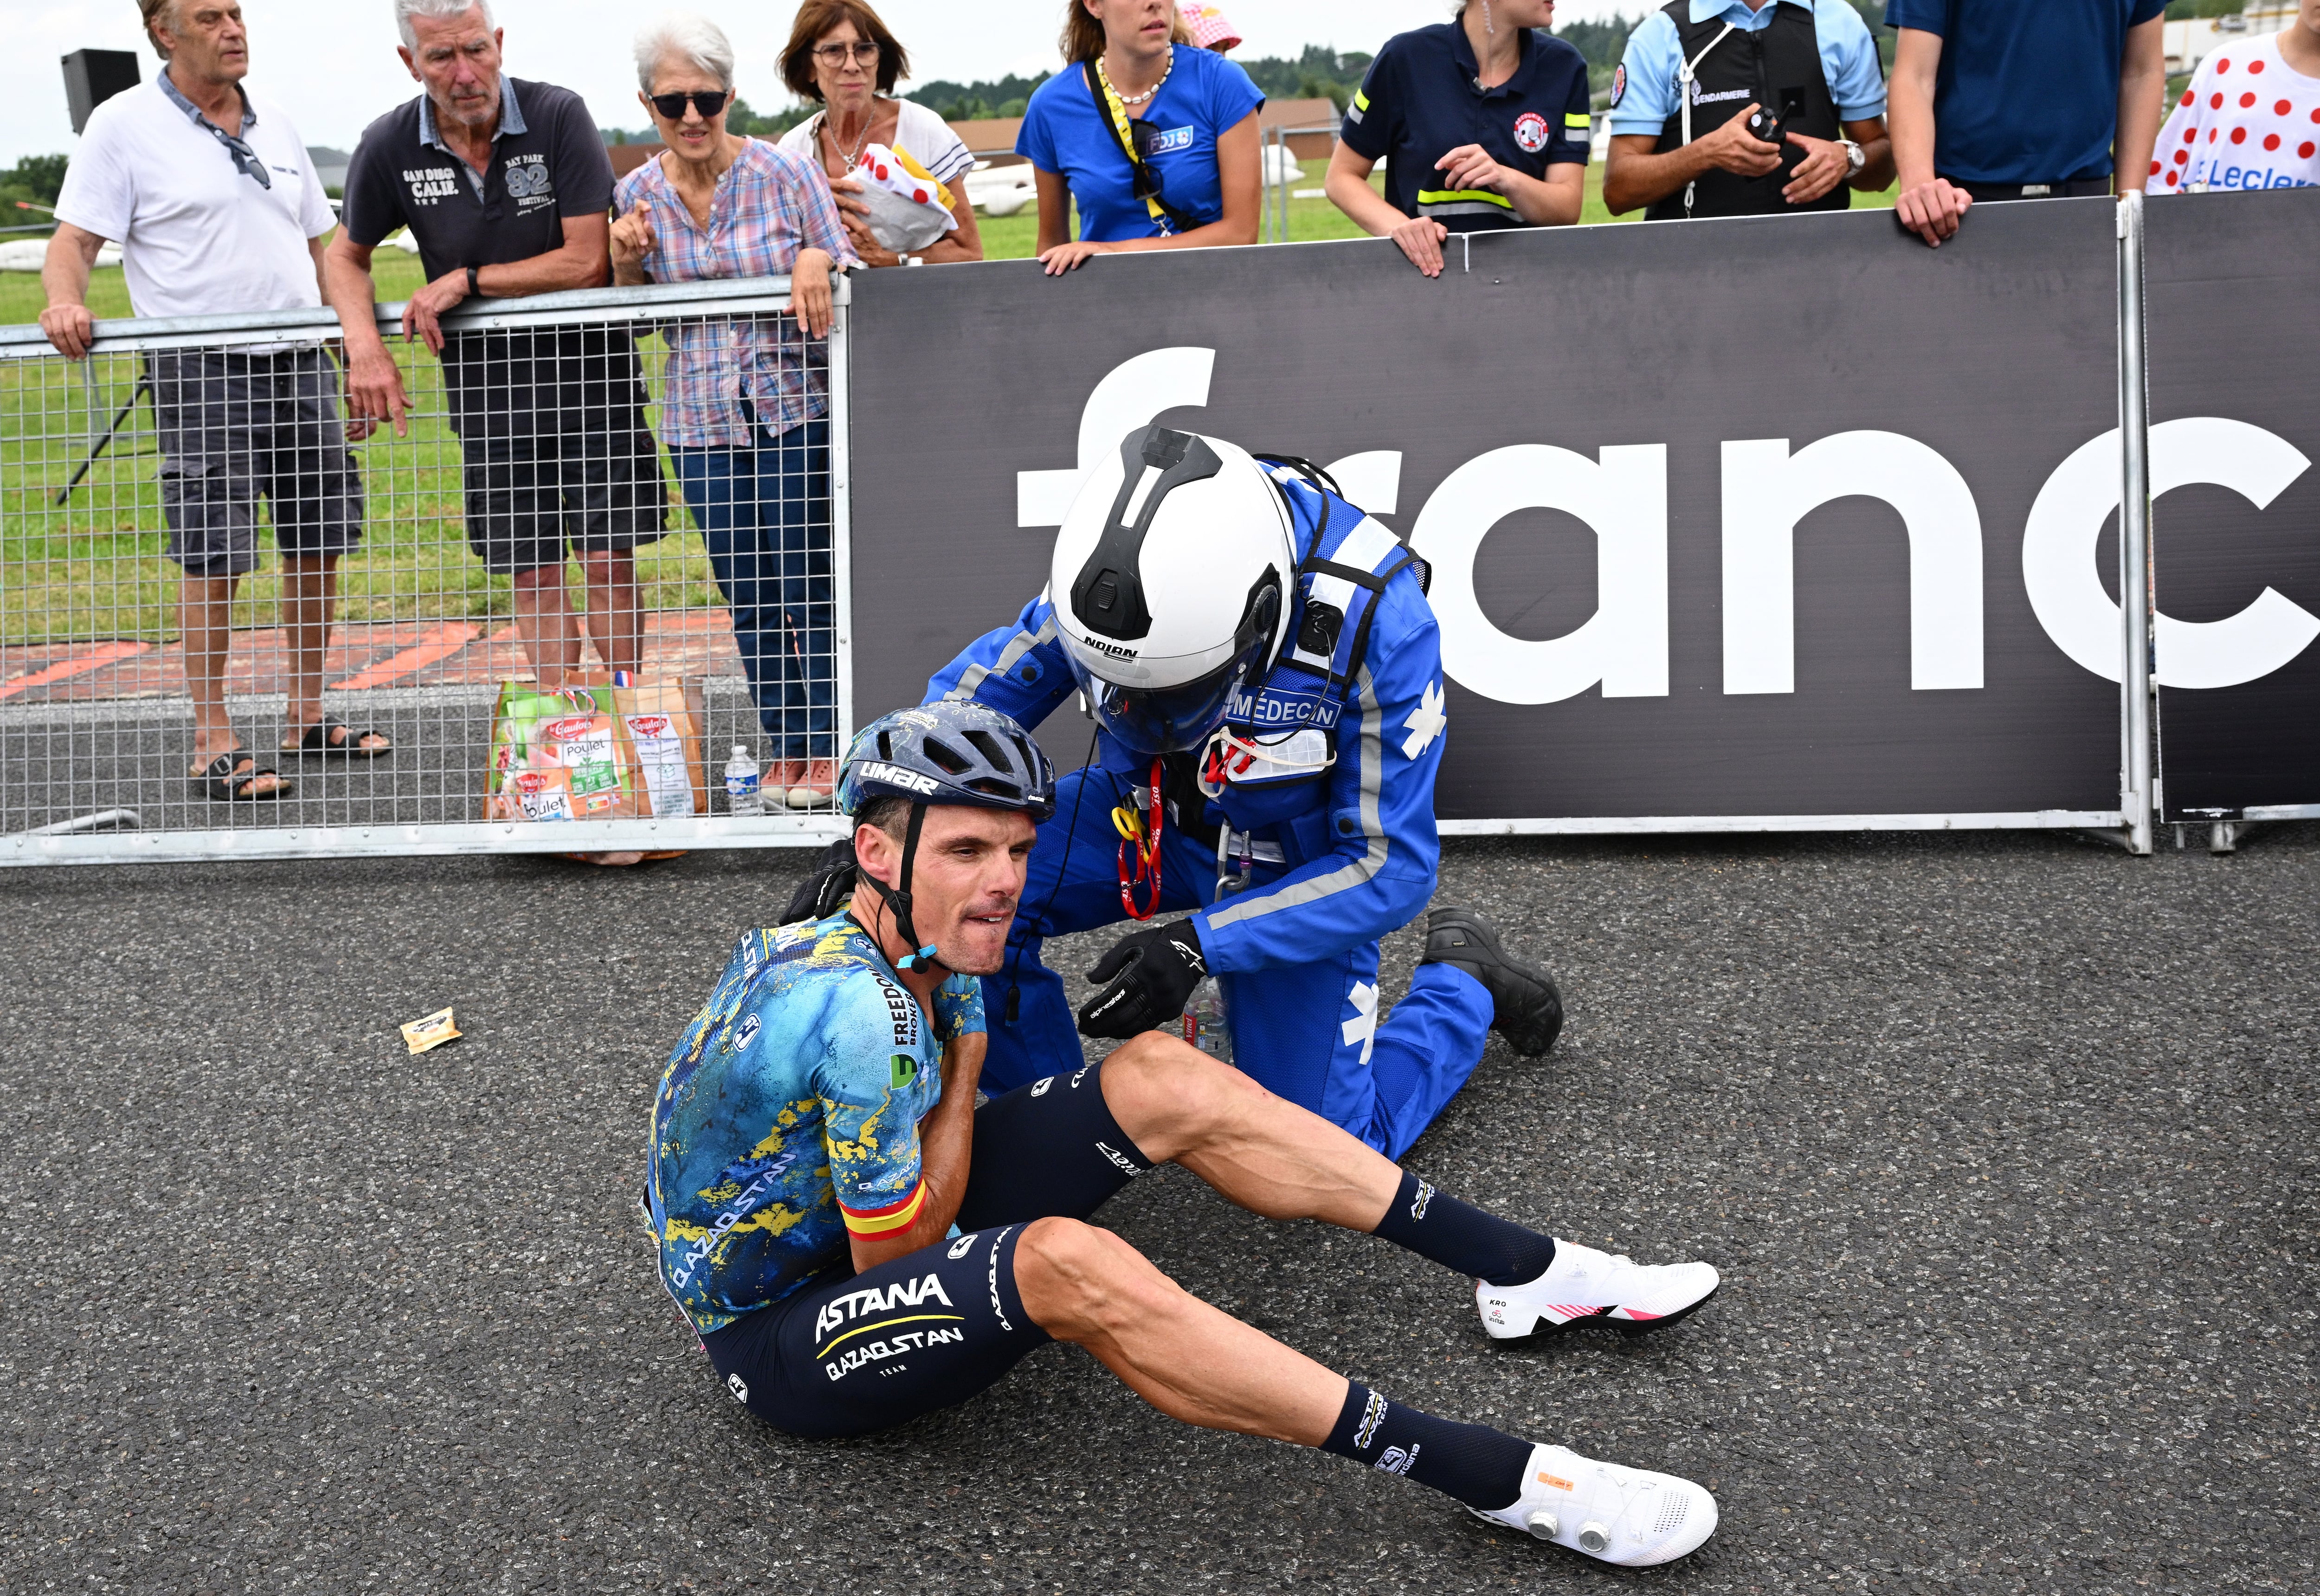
[645,703,1717,1566]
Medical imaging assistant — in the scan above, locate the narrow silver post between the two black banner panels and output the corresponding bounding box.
[2118,193,2153,854]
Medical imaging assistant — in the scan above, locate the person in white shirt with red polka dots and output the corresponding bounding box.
[2148,0,2320,195]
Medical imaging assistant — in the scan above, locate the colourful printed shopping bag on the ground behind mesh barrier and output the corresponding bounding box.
[483,682,650,821]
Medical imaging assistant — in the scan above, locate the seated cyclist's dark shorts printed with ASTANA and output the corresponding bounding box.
[701,1065,1151,1438]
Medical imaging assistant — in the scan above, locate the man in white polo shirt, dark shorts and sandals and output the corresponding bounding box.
[39,0,390,800]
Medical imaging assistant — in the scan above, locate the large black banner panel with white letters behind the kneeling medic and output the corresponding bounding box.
[849,200,2125,824]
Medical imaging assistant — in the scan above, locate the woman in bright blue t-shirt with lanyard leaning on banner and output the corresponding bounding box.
[1016,0,1264,276]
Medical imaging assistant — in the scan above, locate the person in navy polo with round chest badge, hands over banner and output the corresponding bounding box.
[1327,0,1589,276]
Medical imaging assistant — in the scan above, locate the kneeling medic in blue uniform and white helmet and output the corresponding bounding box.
[928,427,1561,1158]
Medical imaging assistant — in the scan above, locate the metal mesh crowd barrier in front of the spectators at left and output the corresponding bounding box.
[0,278,854,865]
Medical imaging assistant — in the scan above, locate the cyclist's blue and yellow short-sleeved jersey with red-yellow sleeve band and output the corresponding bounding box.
[645,914,984,1336]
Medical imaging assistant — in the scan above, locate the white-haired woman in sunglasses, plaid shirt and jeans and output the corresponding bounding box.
[612,14,861,810]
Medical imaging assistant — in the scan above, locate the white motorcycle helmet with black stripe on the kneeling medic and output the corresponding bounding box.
[1046,427,1297,754]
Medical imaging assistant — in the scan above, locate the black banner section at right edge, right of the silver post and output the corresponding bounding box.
[2144,188,2320,821]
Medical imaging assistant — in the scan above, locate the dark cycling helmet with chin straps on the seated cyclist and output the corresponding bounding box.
[838,701,1056,970]
